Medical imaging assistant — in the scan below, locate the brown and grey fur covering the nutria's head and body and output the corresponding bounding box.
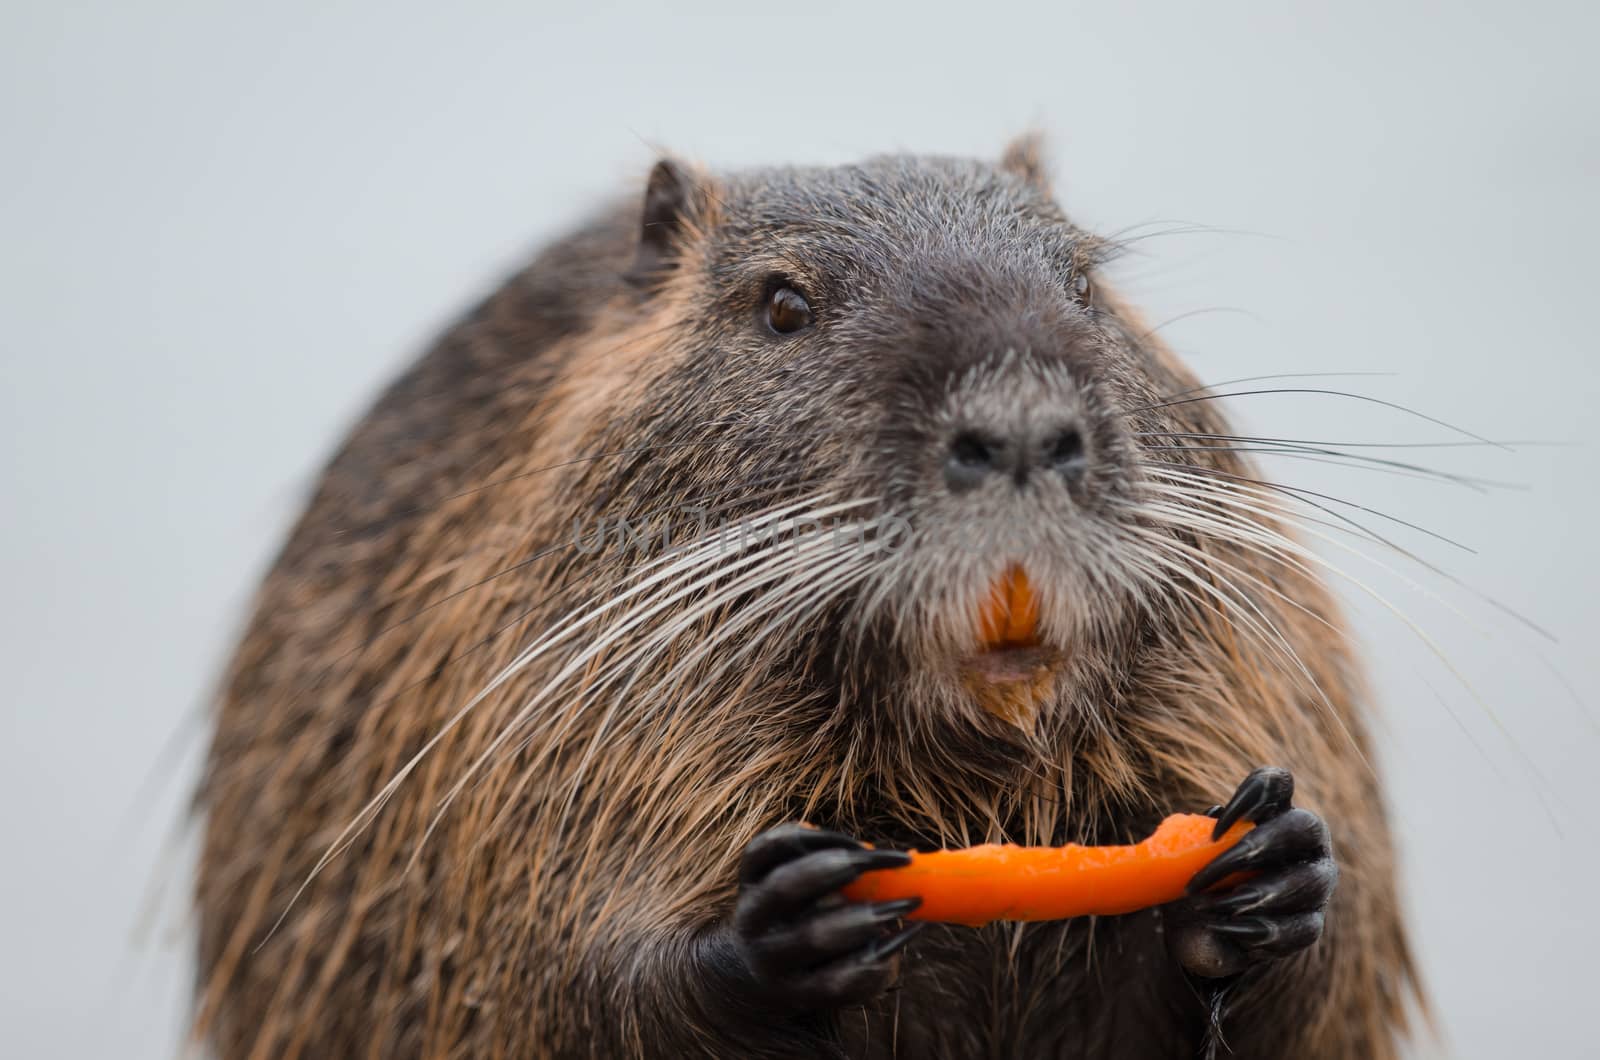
[197,146,1414,1058]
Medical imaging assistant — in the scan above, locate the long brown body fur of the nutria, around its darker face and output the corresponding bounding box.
[197,147,1414,1058]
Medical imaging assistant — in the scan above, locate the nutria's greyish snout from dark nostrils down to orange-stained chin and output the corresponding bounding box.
[889,344,1126,727]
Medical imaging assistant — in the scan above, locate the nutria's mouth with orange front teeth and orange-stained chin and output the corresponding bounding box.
[958,564,1061,729]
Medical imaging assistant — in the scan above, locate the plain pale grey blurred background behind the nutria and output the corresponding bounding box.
[0,0,1600,1057]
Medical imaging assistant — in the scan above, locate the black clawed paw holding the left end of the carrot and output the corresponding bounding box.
[733,825,922,1012]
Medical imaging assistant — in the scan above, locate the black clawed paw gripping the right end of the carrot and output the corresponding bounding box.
[1166,769,1339,978]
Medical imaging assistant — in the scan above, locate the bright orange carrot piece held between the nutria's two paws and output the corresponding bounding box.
[845,813,1251,927]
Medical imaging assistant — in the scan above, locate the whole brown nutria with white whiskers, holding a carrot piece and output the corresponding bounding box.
[197,139,1419,1058]
